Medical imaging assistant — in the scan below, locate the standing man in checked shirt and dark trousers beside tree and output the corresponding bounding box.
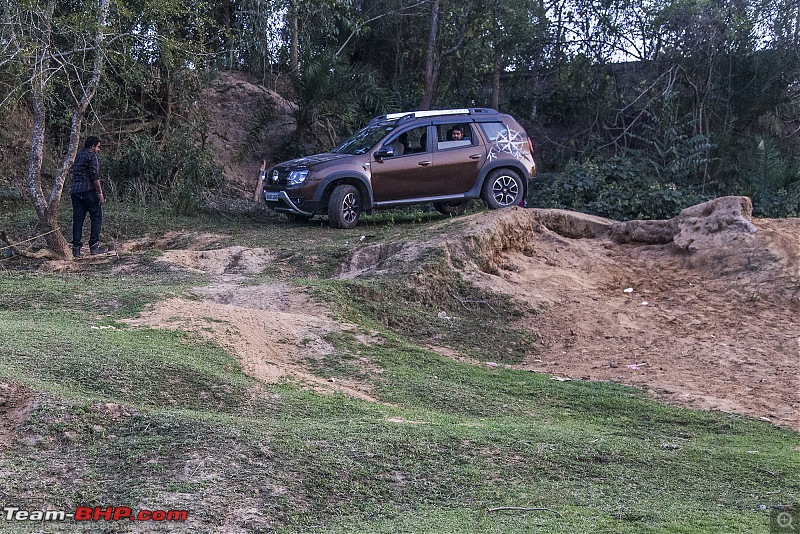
[70,135,108,258]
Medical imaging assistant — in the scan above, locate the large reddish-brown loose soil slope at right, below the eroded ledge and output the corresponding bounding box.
[454,202,800,430]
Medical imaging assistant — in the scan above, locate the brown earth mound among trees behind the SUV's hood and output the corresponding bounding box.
[204,71,295,198]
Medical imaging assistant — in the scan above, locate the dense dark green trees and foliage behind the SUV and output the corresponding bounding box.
[0,0,800,220]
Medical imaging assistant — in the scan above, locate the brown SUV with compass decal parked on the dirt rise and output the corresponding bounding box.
[262,108,536,228]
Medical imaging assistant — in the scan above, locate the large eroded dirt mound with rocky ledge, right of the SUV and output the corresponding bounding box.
[342,197,800,429]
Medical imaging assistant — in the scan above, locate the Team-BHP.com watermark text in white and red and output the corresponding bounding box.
[0,506,189,522]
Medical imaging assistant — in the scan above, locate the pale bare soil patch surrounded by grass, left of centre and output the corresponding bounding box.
[122,280,377,402]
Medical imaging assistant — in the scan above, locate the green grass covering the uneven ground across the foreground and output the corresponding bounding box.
[0,203,800,533]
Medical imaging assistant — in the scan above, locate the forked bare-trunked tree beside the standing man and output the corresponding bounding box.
[2,0,109,258]
